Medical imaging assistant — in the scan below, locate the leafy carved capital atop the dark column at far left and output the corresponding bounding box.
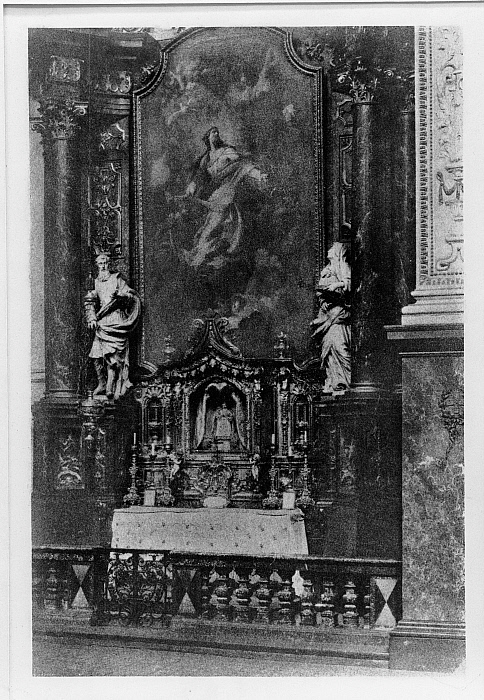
[32,98,87,144]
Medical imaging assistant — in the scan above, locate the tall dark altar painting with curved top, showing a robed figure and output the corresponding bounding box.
[133,27,323,365]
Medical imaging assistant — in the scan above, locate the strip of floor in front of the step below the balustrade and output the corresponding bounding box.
[33,635,442,677]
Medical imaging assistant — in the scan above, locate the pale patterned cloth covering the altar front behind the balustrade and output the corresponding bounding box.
[111,506,308,556]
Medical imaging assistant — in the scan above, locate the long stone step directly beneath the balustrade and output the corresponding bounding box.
[33,611,389,668]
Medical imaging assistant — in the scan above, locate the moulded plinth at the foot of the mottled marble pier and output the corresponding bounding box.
[389,620,465,673]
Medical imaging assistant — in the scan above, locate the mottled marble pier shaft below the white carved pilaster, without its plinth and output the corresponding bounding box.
[402,354,464,622]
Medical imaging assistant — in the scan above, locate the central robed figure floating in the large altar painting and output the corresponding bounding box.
[182,126,267,268]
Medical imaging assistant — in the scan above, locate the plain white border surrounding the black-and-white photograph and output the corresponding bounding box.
[0,0,484,700]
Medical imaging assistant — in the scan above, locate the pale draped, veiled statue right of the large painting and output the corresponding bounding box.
[312,243,351,393]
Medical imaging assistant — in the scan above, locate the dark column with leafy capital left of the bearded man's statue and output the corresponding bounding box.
[34,98,87,399]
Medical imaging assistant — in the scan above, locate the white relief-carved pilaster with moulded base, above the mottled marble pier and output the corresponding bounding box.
[402,27,464,325]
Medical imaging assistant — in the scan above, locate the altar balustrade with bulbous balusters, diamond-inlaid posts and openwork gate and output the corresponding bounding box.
[33,547,401,629]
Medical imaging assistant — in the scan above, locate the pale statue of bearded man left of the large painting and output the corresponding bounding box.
[84,252,141,399]
